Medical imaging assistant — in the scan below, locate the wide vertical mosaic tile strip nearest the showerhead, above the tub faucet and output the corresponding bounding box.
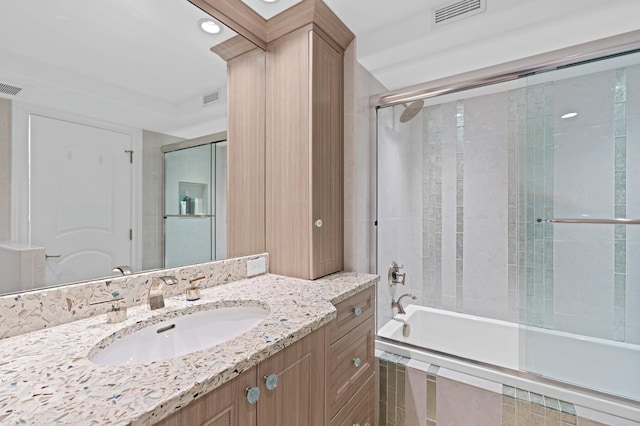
[422,105,442,308]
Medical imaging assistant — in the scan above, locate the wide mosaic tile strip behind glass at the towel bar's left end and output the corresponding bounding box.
[522,83,555,328]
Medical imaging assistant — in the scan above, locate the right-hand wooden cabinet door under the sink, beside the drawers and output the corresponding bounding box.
[258,328,324,426]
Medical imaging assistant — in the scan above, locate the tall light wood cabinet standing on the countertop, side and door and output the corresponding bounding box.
[265,25,344,279]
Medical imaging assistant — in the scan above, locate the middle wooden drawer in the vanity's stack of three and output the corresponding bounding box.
[327,317,374,418]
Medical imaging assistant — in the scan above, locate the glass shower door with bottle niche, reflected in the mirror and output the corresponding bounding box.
[164,144,226,267]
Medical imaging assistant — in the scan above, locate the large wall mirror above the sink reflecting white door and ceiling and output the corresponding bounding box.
[0,0,252,293]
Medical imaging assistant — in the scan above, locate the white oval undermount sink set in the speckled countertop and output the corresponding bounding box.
[89,306,270,365]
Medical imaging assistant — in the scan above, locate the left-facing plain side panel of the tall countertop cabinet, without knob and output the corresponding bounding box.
[266,29,311,278]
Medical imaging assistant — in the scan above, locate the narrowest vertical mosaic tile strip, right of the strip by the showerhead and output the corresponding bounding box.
[456,101,464,312]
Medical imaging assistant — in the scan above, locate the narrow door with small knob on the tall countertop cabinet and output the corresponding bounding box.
[309,31,344,279]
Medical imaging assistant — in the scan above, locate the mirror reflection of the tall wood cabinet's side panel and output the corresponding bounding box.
[227,49,266,257]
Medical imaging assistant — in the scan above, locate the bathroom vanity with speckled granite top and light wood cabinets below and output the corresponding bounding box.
[0,273,378,426]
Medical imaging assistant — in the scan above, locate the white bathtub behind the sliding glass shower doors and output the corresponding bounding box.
[376,305,640,421]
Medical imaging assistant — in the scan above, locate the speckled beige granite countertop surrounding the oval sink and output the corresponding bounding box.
[0,273,378,425]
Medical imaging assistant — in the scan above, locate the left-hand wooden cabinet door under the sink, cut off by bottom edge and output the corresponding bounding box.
[156,367,257,426]
